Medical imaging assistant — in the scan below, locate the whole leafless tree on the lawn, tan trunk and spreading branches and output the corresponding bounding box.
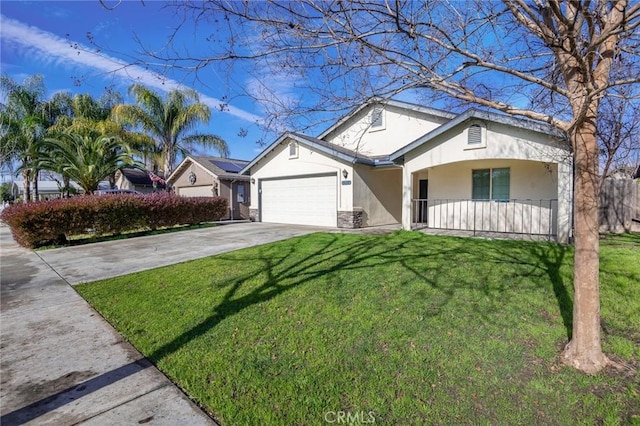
[131,0,640,373]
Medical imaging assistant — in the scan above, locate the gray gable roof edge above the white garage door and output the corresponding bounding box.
[240,132,392,174]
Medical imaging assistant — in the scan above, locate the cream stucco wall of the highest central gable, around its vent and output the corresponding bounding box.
[323,105,447,156]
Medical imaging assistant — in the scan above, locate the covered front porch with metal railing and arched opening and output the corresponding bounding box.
[403,159,571,242]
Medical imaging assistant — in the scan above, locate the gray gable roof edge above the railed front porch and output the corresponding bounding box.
[389,108,566,161]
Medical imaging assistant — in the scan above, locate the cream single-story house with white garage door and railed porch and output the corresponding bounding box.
[241,100,572,241]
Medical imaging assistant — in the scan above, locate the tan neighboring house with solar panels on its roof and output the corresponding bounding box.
[167,155,251,219]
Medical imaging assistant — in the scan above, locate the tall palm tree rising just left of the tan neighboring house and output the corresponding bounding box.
[113,84,229,176]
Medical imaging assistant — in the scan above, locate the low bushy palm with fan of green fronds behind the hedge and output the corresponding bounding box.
[40,132,142,194]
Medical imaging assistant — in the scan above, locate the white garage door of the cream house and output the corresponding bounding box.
[260,174,338,227]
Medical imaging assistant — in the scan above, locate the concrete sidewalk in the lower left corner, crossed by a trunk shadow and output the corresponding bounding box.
[0,226,215,425]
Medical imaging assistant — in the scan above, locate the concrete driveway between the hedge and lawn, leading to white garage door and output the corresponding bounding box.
[37,222,327,285]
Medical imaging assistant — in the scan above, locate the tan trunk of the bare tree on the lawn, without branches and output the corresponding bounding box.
[562,116,609,374]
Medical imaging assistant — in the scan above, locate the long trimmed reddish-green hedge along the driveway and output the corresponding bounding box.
[0,193,228,248]
